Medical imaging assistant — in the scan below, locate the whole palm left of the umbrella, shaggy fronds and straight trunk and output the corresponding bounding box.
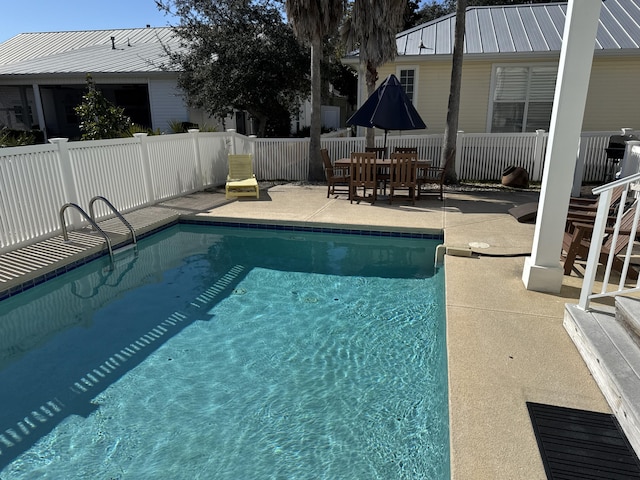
[287,0,344,180]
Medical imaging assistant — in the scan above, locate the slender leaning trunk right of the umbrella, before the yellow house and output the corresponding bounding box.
[440,0,467,184]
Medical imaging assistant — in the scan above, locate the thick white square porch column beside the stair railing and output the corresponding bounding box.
[522,0,602,293]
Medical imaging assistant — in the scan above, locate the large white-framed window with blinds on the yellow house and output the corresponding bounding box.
[490,66,558,133]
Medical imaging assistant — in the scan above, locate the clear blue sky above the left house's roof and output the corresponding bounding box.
[0,0,176,42]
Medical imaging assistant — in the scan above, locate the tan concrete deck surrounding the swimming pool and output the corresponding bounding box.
[0,184,610,480]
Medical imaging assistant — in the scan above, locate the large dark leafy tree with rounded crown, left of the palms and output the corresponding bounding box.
[156,0,309,137]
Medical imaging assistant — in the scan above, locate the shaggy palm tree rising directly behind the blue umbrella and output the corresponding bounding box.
[342,0,407,147]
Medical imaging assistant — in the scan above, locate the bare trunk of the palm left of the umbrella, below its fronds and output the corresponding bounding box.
[309,35,324,181]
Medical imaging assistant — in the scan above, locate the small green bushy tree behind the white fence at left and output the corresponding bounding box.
[74,74,132,140]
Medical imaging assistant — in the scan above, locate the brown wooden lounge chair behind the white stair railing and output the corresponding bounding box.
[562,202,638,279]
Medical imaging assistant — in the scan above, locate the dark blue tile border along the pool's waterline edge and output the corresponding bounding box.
[0,217,444,302]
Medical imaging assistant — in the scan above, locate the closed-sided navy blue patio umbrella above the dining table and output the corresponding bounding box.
[347,75,427,147]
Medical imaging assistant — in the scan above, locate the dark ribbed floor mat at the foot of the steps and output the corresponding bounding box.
[527,402,640,480]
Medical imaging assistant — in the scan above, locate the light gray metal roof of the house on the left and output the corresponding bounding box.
[0,27,178,75]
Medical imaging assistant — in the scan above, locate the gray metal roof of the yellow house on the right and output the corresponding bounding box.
[396,0,640,55]
